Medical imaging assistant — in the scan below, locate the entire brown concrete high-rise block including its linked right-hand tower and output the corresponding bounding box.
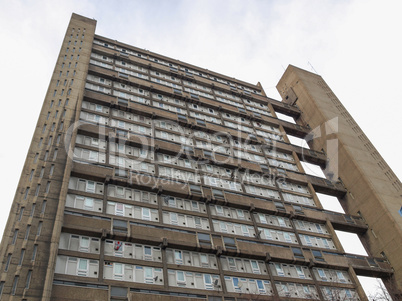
[0,14,401,301]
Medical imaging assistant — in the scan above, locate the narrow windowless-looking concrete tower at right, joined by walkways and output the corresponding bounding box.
[277,66,402,296]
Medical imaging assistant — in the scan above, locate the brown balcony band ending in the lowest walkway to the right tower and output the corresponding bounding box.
[63,214,392,277]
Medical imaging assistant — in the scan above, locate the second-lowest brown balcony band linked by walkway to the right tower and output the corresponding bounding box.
[68,162,367,239]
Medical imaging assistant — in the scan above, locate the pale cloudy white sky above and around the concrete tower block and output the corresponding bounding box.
[0,0,402,296]
